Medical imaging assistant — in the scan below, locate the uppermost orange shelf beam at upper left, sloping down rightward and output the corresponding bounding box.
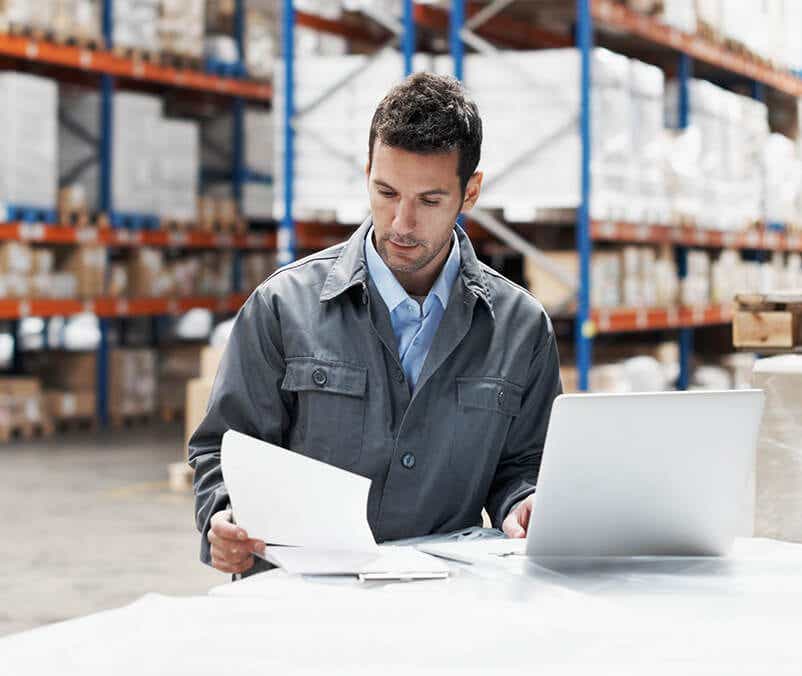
[0,34,273,101]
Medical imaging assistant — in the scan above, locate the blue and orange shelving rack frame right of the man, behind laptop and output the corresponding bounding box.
[440,0,802,390]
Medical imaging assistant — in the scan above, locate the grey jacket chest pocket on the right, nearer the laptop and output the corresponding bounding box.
[451,378,523,472]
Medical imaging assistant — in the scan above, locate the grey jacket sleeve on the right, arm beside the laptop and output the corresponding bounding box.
[487,318,562,529]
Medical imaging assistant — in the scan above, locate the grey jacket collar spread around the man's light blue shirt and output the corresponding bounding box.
[320,217,495,318]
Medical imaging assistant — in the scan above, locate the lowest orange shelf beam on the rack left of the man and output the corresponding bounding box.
[0,294,248,319]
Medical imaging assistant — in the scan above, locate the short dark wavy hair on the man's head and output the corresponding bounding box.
[368,73,482,194]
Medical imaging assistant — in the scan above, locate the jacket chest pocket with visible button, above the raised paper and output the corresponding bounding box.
[281,357,368,468]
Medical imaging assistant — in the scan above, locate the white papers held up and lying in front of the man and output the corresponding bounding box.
[222,430,448,579]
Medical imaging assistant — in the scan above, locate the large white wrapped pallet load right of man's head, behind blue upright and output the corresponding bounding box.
[435,48,636,221]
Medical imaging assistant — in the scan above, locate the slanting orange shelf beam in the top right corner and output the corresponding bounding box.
[590,0,802,96]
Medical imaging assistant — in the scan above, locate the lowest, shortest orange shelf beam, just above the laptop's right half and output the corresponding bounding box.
[591,305,733,334]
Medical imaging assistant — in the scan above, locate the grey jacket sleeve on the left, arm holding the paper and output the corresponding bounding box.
[189,287,291,564]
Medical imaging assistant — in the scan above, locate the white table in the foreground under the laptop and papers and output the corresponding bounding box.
[0,540,802,676]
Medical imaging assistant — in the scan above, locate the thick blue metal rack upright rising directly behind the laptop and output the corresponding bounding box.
[574,0,594,392]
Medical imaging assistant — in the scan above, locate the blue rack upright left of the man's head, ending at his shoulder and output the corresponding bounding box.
[278,0,295,265]
